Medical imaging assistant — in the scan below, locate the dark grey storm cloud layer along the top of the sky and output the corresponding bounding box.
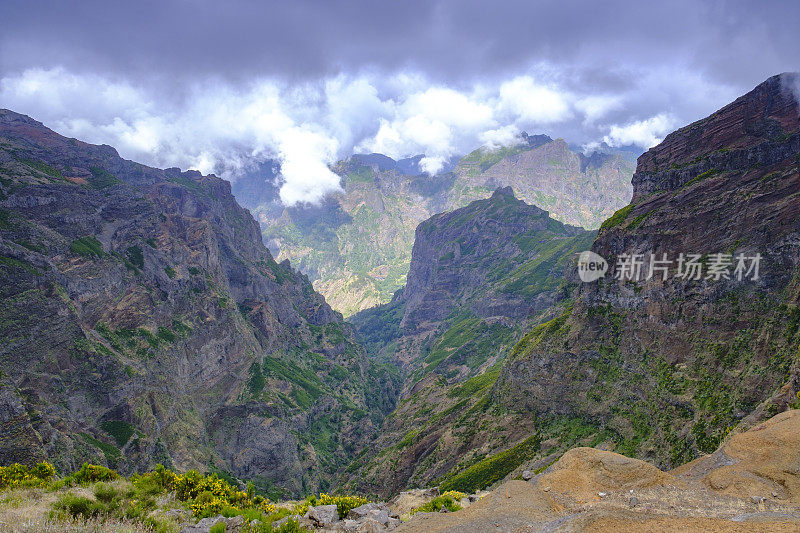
[0,0,800,84]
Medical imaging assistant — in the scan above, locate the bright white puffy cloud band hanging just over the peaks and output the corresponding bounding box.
[0,62,736,204]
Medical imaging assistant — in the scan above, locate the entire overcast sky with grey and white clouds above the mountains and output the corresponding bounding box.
[0,0,800,204]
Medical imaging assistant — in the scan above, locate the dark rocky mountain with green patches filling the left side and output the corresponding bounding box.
[0,110,400,494]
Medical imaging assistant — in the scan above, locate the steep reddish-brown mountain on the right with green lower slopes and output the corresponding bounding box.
[340,74,800,491]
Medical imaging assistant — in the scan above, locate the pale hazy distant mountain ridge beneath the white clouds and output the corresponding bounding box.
[245,135,634,316]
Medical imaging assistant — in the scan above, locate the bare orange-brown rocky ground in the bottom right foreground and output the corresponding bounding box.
[397,410,800,533]
